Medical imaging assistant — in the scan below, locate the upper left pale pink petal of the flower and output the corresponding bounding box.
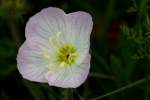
[26,7,66,39]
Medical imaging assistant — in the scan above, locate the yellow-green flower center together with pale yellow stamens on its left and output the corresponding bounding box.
[41,32,78,67]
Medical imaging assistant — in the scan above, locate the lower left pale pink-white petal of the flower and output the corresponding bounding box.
[17,42,47,82]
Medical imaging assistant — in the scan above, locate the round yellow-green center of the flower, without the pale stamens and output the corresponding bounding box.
[56,43,78,66]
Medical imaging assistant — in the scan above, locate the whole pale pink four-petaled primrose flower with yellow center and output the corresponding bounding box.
[17,7,93,88]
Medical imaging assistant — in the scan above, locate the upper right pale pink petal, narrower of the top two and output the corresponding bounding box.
[66,11,93,49]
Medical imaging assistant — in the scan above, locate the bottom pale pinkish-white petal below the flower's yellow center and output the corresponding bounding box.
[47,55,91,88]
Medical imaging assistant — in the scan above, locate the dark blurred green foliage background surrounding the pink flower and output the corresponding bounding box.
[0,0,150,100]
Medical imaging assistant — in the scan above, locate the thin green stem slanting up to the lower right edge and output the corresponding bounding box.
[91,77,150,100]
